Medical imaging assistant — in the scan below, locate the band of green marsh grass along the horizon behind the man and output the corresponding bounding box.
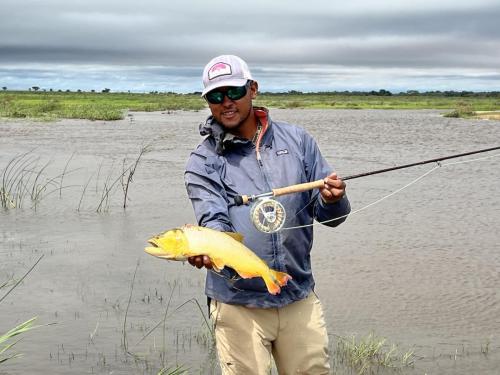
[0,90,500,120]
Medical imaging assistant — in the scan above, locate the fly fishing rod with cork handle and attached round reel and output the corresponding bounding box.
[234,146,500,233]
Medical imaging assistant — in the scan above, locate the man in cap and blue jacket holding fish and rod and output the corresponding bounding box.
[185,55,350,374]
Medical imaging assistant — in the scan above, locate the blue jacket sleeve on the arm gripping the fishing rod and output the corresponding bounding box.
[303,133,351,227]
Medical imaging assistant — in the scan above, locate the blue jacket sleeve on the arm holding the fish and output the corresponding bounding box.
[184,153,234,231]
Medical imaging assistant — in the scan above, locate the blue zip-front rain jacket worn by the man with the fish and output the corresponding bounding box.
[184,108,350,307]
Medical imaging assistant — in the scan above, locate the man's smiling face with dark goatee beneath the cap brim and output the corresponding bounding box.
[205,81,258,135]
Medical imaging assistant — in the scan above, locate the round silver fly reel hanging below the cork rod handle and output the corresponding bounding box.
[250,198,286,233]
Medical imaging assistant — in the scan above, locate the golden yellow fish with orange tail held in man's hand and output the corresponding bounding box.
[144,225,292,294]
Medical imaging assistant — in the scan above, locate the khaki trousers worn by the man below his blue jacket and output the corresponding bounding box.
[210,293,330,375]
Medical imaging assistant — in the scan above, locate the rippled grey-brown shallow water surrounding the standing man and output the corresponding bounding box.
[0,110,500,374]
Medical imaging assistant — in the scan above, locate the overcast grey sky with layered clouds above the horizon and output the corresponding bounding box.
[0,0,500,92]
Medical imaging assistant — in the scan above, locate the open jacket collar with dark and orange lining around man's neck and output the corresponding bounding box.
[199,107,273,155]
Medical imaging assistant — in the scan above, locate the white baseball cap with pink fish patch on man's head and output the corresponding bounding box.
[201,55,252,96]
